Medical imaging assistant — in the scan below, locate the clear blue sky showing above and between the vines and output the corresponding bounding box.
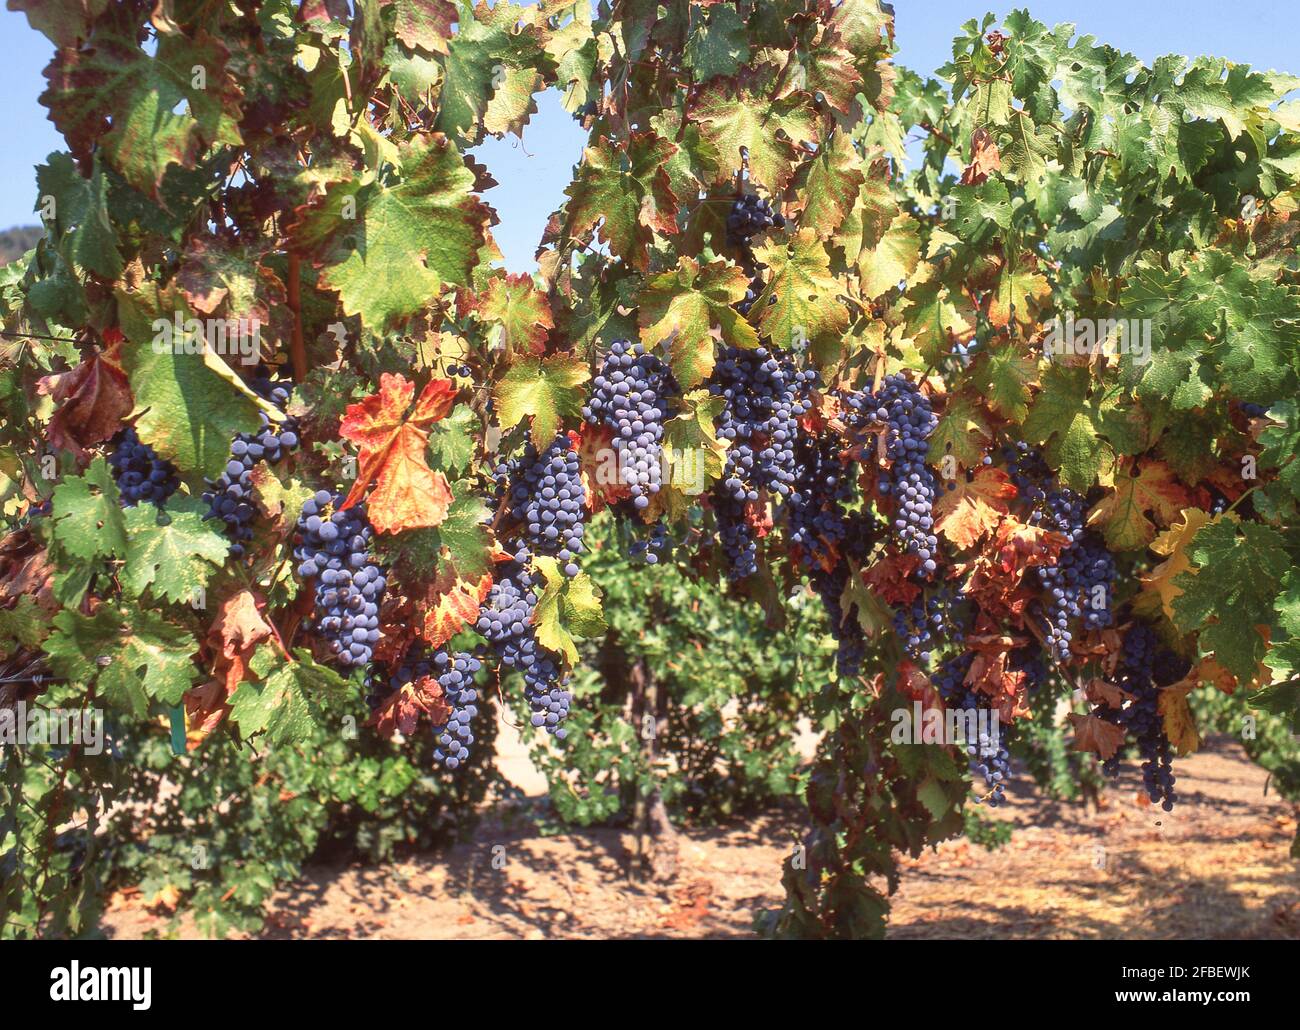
[0,0,1300,272]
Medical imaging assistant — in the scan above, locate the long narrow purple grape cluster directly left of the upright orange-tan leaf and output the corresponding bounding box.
[845,373,939,576]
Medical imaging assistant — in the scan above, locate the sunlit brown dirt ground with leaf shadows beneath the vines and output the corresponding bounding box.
[104,741,1300,939]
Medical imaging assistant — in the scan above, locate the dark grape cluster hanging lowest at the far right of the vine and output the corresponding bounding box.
[1093,623,1190,812]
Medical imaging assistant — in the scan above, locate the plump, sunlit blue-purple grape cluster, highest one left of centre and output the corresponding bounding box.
[582,339,677,510]
